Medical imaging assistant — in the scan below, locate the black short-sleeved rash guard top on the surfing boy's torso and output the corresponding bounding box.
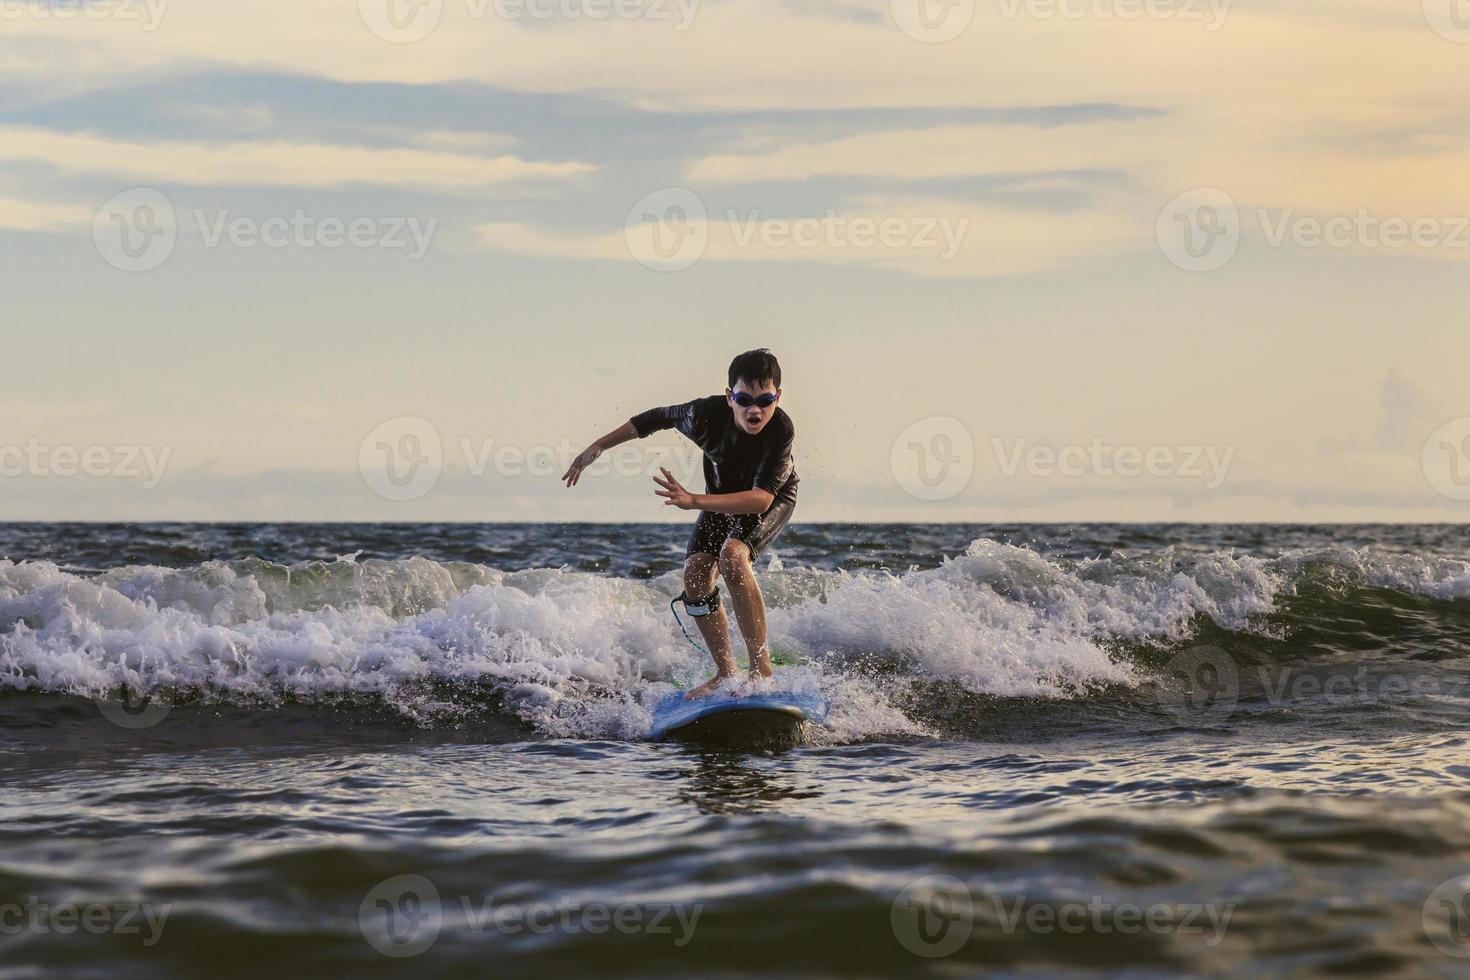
[629,395,797,498]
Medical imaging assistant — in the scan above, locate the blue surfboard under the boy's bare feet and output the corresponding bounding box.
[650,691,828,743]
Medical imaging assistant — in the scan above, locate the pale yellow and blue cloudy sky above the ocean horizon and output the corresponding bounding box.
[0,0,1470,522]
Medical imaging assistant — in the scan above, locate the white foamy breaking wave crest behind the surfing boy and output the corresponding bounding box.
[0,539,1470,741]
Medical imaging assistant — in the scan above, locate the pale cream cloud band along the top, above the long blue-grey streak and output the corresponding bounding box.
[0,0,1463,113]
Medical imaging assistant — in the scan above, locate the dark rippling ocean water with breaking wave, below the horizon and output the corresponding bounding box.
[0,525,1470,979]
